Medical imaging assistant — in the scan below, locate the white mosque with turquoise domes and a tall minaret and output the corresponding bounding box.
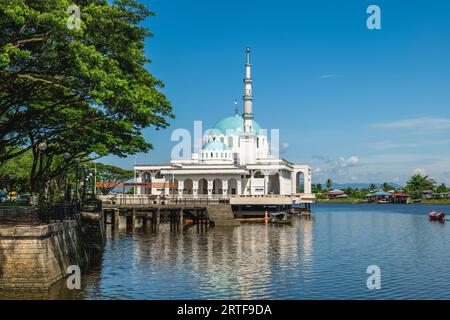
[134,48,315,208]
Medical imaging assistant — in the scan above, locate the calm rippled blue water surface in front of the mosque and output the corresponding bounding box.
[0,204,450,299]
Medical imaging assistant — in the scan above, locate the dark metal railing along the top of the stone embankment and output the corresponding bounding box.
[0,203,81,226]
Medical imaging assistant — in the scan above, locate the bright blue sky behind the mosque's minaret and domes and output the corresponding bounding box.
[100,0,450,183]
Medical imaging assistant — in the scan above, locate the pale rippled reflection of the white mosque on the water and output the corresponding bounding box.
[129,220,313,299]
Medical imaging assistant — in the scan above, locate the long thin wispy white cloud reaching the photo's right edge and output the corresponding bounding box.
[374,117,450,131]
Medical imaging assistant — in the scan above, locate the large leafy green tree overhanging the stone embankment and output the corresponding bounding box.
[0,0,174,191]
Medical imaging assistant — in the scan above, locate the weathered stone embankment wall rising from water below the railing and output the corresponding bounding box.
[0,213,105,291]
